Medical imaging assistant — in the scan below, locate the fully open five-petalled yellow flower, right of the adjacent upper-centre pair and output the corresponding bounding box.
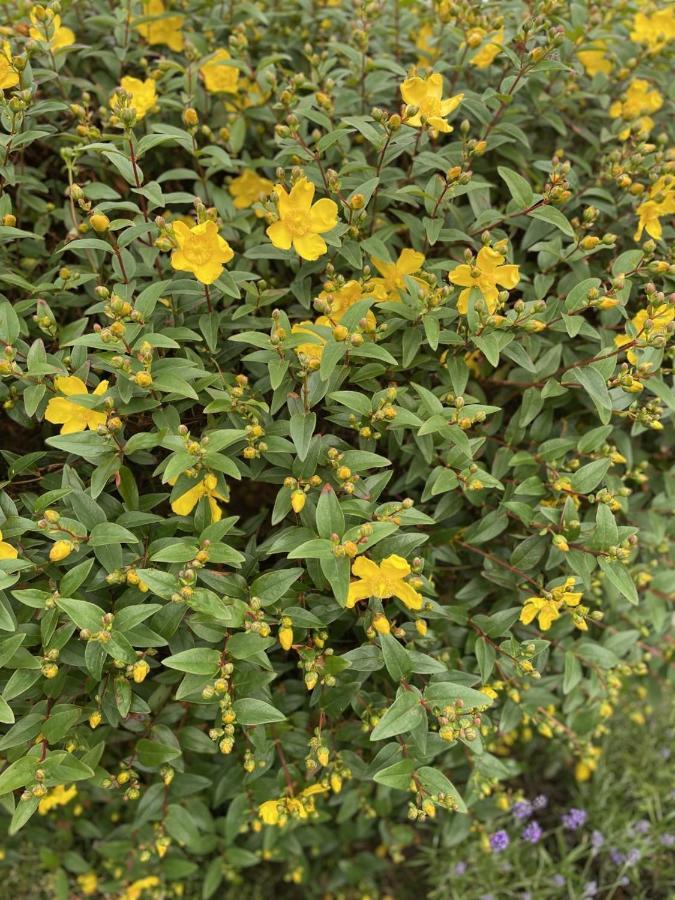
[267,178,338,260]
